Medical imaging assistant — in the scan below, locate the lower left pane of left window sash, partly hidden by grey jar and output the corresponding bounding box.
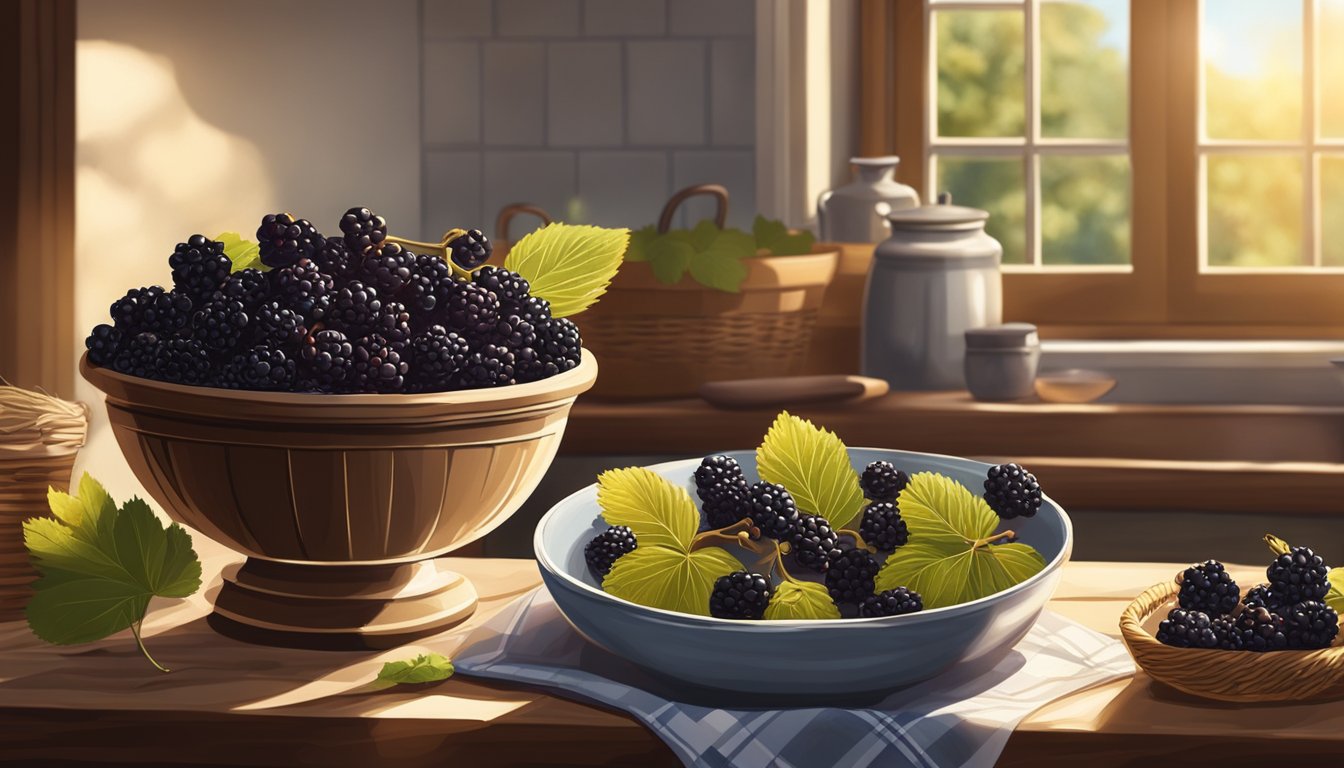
[935,155,1032,264]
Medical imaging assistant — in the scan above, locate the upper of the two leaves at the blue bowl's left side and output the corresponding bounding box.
[597,467,700,560]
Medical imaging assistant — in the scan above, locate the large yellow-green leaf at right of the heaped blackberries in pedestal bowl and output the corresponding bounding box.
[504,222,630,317]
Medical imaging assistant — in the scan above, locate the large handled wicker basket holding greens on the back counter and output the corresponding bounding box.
[578,184,839,399]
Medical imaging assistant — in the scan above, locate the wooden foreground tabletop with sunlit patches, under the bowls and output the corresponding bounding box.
[0,538,1344,768]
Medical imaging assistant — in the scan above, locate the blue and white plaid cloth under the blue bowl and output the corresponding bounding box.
[453,588,1134,768]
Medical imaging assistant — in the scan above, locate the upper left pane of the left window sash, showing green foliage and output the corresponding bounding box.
[933,11,1025,136]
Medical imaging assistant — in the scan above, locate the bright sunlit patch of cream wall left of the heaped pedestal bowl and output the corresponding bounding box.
[75,40,276,499]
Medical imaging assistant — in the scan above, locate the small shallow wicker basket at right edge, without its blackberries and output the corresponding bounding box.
[1120,581,1344,703]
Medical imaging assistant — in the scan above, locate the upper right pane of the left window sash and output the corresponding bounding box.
[1040,0,1129,139]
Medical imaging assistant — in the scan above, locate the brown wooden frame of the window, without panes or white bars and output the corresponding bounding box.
[860,0,1344,339]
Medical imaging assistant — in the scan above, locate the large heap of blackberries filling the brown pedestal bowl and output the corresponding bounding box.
[86,208,581,393]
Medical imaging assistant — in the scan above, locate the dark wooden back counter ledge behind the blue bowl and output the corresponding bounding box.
[560,391,1344,514]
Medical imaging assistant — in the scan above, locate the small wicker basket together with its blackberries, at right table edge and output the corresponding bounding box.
[1120,534,1344,703]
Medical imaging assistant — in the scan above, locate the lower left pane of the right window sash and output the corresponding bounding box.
[1206,155,1312,266]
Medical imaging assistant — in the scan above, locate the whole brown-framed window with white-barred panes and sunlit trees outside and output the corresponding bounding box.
[862,0,1344,338]
